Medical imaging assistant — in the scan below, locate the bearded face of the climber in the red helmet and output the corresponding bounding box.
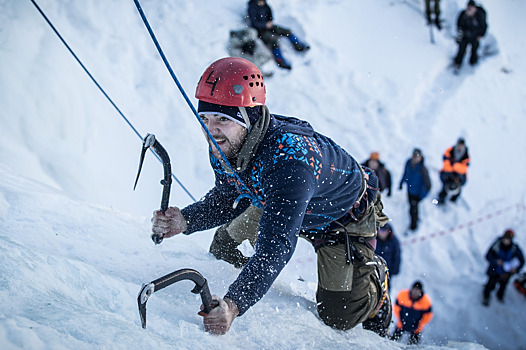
[200,114,247,159]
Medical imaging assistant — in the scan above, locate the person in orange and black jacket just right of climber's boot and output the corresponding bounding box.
[391,281,433,344]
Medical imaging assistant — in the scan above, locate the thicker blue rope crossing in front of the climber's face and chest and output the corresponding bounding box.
[133,0,259,203]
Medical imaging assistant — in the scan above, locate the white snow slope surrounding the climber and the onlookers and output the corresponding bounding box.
[0,0,526,349]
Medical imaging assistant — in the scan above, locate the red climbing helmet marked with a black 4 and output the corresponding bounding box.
[195,57,265,107]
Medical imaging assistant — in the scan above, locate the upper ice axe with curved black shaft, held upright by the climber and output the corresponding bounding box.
[133,134,172,244]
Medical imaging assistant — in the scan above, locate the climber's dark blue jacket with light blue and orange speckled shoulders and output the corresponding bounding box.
[182,115,364,315]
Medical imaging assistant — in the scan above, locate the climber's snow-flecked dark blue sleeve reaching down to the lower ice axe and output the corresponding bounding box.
[225,161,316,316]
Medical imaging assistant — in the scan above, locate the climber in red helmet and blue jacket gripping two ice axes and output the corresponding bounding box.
[152,57,391,335]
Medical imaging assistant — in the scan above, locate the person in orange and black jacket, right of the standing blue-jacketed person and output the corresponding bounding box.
[438,138,469,204]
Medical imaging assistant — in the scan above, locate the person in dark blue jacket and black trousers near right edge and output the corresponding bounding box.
[482,229,524,306]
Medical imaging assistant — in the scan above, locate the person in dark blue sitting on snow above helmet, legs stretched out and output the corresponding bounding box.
[248,0,310,69]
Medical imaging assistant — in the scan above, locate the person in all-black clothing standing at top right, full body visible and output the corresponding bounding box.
[454,0,488,69]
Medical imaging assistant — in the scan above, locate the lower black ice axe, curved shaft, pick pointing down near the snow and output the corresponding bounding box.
[137,269,218,329]
